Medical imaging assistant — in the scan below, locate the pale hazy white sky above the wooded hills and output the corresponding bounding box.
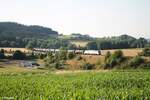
[0,0,150,38]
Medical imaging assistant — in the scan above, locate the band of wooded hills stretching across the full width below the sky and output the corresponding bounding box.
[0,22,150,50]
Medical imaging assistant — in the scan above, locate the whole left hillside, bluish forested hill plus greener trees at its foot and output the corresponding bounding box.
[0,22,60,48]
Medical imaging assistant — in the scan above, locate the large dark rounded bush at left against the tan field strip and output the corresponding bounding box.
[12,50,26,60]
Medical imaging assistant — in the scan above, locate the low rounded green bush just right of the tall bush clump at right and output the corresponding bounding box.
[129,56,144,68]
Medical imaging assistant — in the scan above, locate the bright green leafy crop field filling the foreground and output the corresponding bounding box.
[0,70,150,100]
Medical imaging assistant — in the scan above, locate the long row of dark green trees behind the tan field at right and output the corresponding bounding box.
[87,35,150,50]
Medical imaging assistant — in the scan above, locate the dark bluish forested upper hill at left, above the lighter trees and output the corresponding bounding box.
[0,22,58,39]
